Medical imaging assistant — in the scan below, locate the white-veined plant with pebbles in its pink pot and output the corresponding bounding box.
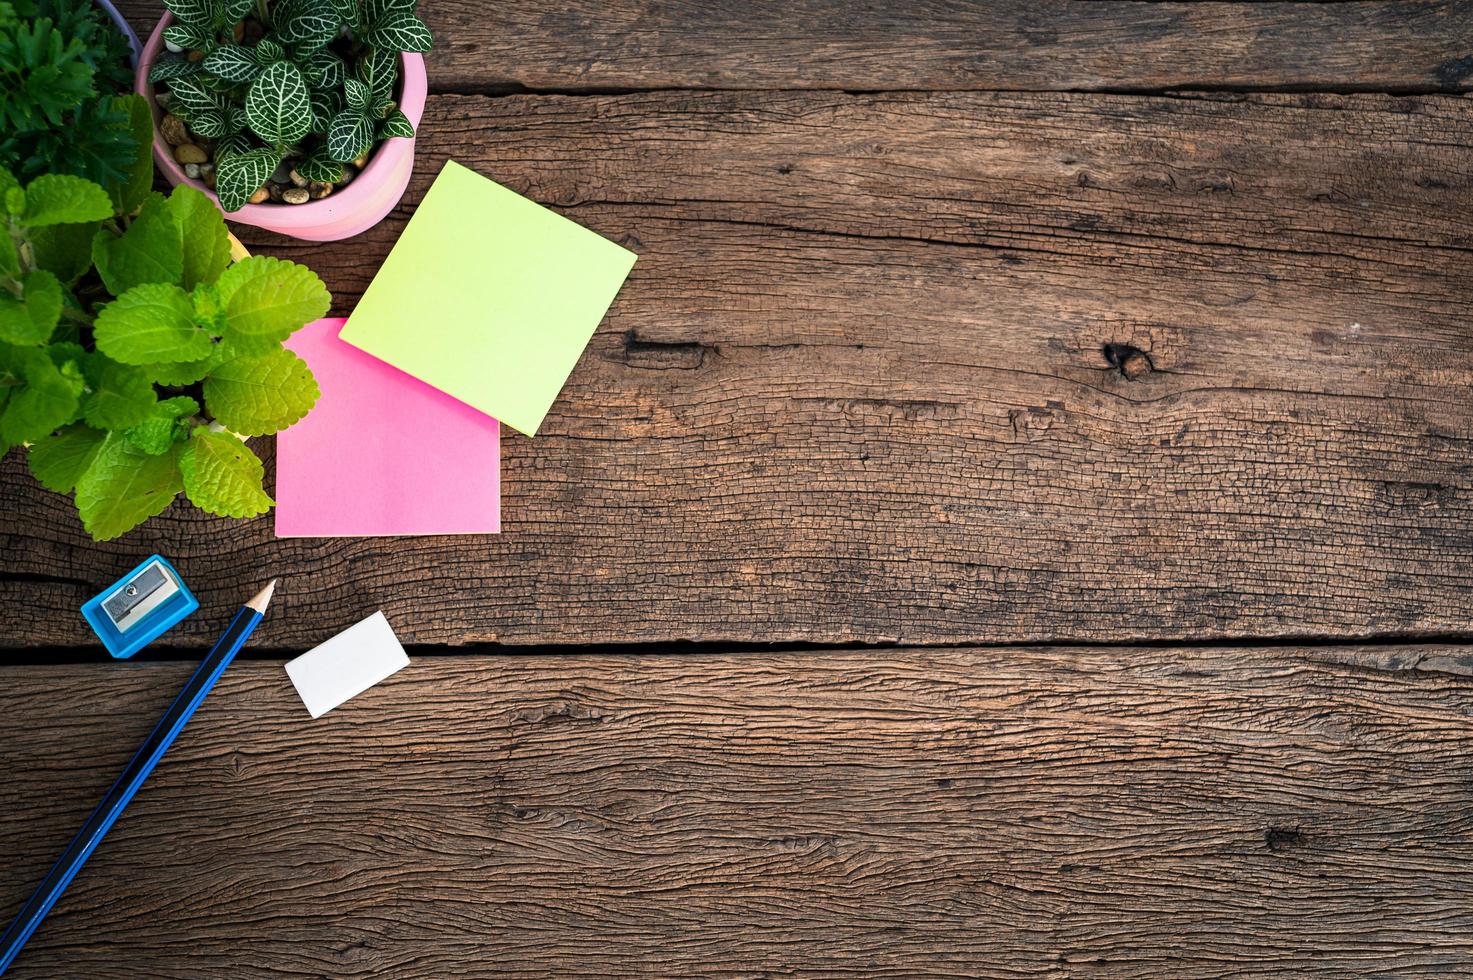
[136,0,430,242]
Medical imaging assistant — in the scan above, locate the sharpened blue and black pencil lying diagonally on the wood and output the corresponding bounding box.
[0,579,275,974]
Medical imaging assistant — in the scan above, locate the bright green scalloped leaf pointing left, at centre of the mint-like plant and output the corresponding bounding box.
[93,283,212,365]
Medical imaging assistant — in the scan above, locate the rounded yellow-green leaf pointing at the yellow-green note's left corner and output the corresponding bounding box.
[218,255,333,354]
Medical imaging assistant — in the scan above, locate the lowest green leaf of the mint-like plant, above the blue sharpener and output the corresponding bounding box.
[77,433,184,541]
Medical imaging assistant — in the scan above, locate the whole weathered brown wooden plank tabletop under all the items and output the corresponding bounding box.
[0,0,1473,980]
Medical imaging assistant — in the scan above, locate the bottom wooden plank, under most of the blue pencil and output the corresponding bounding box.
[0,647,1473,980]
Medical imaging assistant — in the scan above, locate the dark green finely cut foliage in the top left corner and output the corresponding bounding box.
[0,0,142,183]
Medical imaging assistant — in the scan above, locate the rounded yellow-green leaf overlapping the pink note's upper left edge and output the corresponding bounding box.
[205,348,318,436]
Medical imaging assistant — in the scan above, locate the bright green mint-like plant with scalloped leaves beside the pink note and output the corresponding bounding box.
[0,169,330,541]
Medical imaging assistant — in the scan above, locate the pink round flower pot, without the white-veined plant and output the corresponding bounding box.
[134,13,427,242]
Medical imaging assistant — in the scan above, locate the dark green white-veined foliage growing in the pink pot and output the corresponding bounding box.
[149,0,432,211]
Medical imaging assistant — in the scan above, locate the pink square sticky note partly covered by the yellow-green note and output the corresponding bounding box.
[275,318,501,538]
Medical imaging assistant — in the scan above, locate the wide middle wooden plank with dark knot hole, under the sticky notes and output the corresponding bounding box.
[0,93,1473,648]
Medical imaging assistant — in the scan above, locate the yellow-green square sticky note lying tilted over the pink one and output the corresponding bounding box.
[339,162,635,436]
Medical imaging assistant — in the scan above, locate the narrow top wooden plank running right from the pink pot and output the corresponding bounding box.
[121,0,1473,91]
